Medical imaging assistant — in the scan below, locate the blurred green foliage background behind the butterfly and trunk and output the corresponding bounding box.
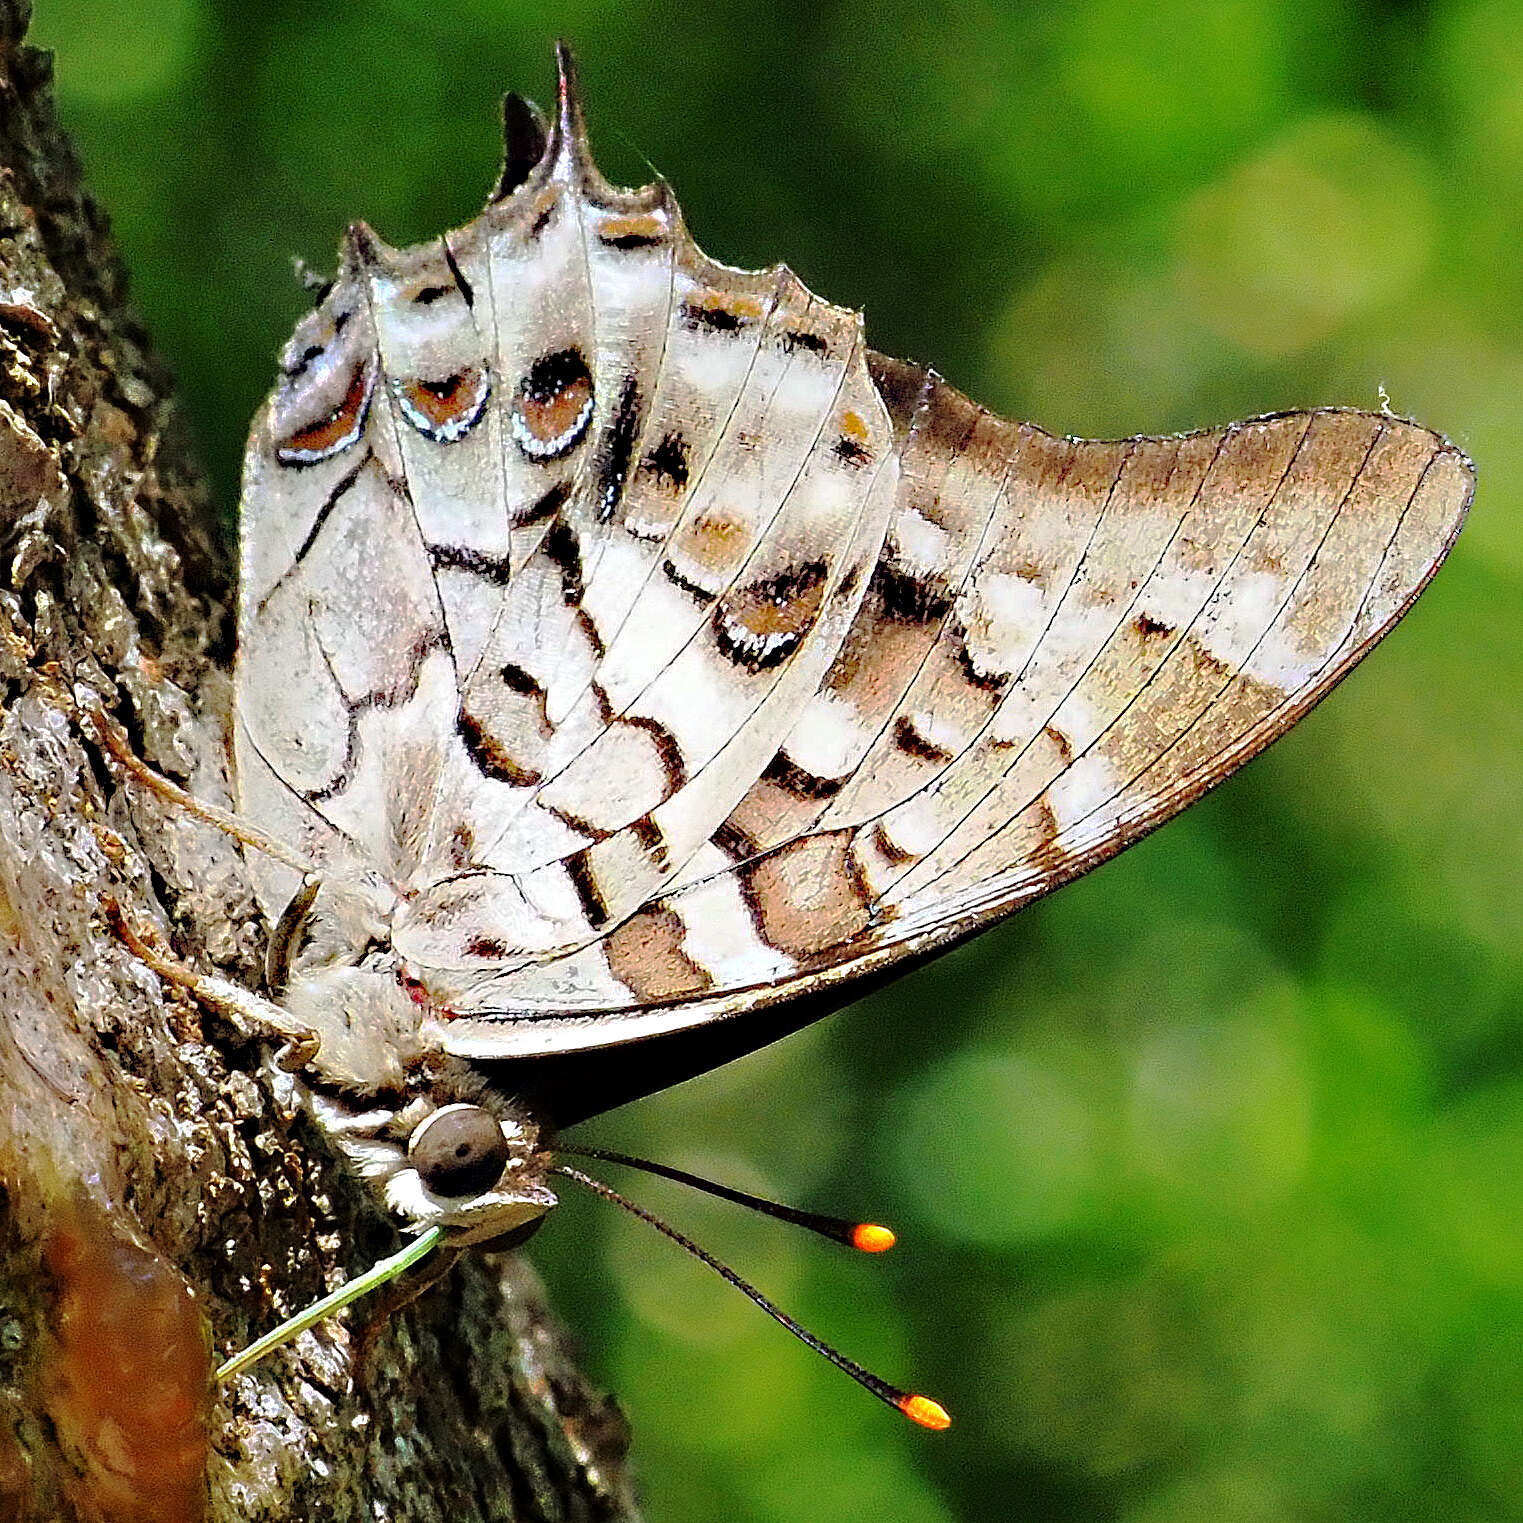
[26,0,1523,1523]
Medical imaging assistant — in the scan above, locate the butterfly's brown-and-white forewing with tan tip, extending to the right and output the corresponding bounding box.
[442,371,1473,1055]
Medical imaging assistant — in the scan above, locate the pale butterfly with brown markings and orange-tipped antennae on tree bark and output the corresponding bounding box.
[184,49,1473,1426]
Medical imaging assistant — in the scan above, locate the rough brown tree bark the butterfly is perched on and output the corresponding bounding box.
[0,0,634,1523]
